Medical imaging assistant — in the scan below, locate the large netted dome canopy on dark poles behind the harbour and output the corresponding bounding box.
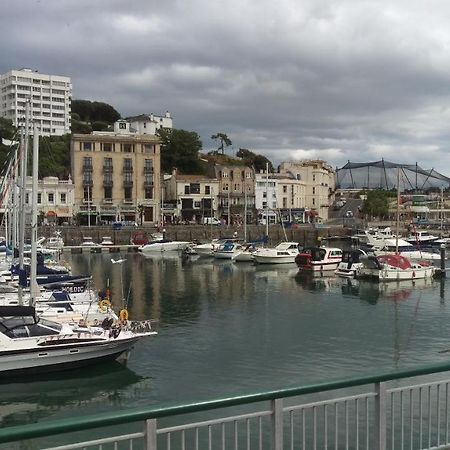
[336,159,450,191]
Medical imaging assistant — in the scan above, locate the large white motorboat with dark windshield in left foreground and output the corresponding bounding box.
[0,306,157,376]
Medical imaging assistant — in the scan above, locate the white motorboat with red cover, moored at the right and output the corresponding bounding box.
[356,254,436,281]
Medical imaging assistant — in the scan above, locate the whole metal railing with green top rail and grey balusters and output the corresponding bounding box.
[0,362,450,450]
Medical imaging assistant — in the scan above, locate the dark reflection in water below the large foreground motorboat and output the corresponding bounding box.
[0,362,151,426]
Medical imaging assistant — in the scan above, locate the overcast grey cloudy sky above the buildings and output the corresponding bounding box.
[0,0,450,176]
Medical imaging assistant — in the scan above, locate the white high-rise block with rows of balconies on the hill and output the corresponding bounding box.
[0,69,72,136]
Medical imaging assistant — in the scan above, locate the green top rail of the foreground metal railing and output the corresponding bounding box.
[0,361,450,443]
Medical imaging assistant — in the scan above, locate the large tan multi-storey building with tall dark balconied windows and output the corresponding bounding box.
[71,120,161,223]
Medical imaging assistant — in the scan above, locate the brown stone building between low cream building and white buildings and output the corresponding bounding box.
[214,164,256,224]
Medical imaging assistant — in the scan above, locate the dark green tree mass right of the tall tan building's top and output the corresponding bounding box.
[157,128,203,174]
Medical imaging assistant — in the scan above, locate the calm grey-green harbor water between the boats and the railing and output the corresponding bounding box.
[0,253,450,427]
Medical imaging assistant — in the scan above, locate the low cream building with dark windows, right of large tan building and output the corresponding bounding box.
[164,169,219,223]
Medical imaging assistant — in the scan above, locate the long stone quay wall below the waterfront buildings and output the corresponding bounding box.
[27,225,351,246]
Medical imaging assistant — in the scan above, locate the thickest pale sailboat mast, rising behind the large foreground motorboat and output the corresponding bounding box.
[30,123,39,306]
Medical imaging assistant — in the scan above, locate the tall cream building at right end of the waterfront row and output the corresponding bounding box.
[279,160,335,220]
